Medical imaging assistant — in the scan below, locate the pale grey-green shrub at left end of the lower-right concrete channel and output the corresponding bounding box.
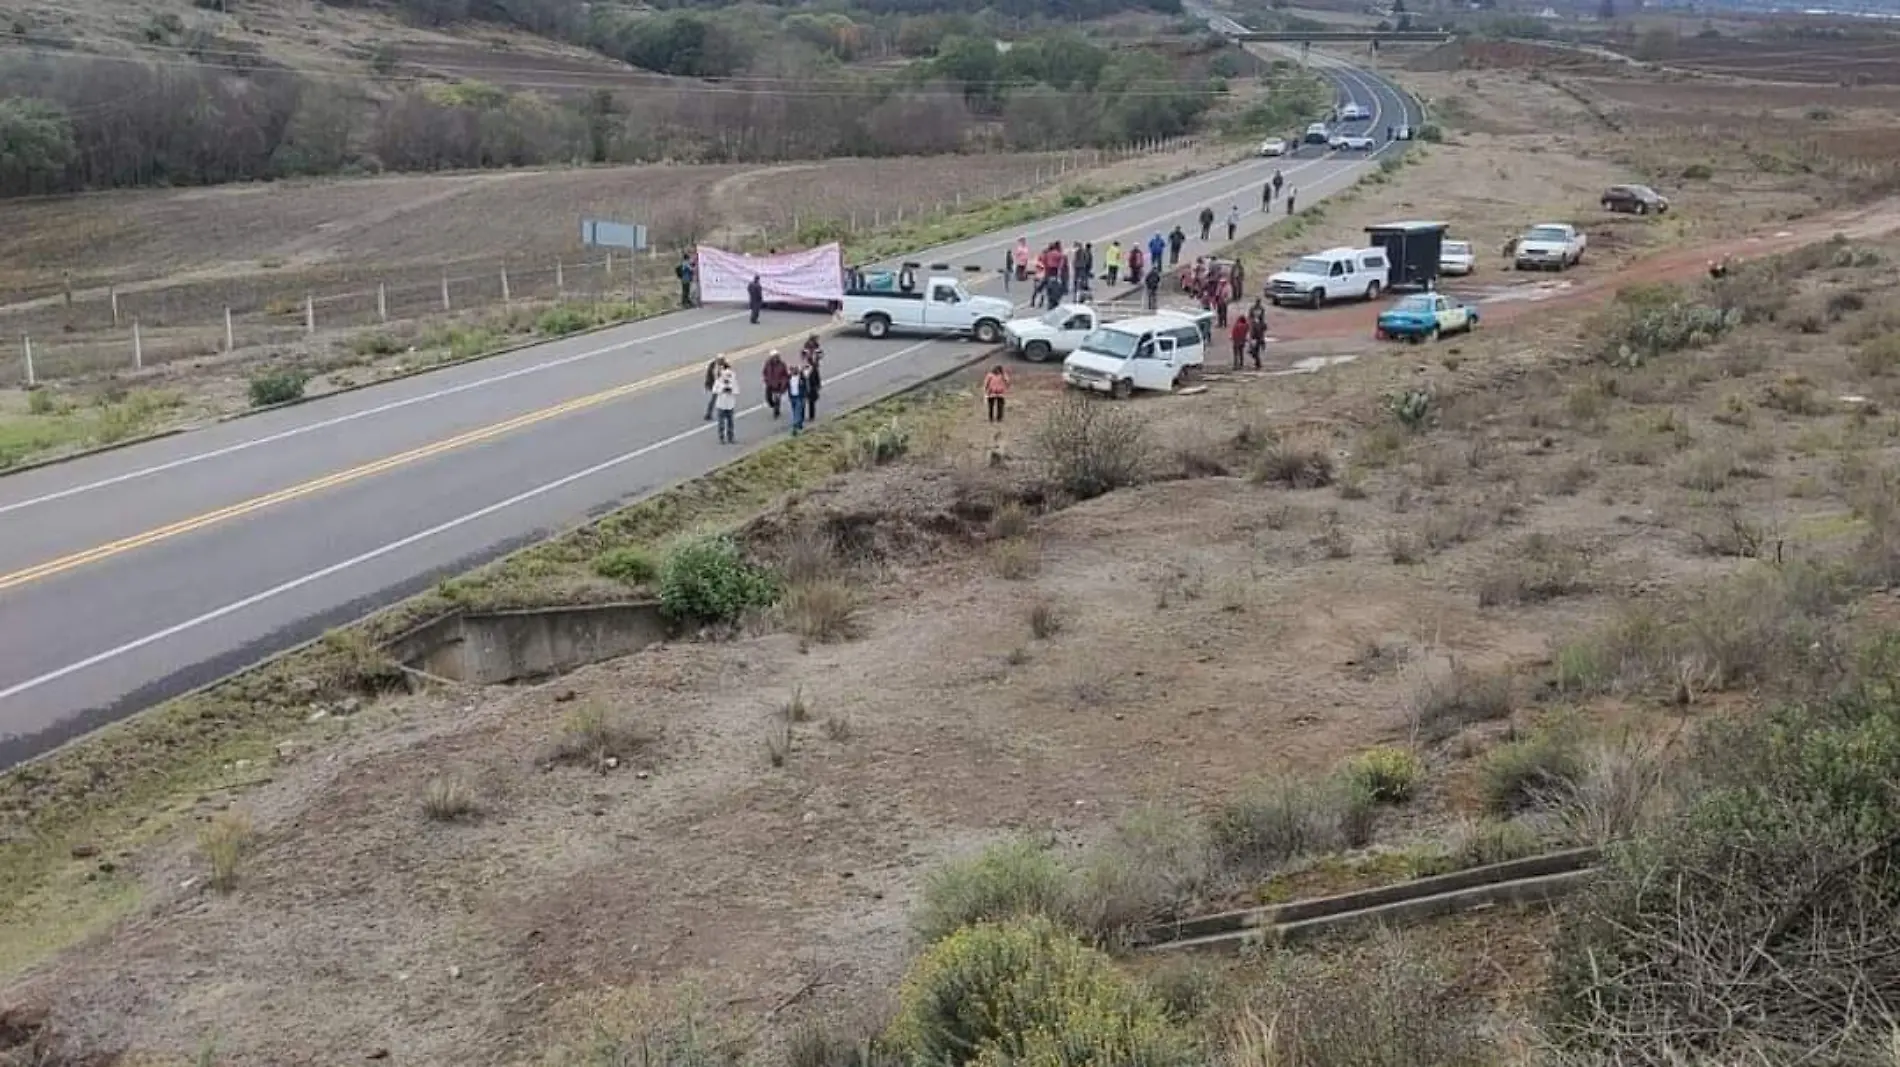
[1074,807,1212,944]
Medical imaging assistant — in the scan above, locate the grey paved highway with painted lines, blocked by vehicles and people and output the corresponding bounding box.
[0,55,1419,767]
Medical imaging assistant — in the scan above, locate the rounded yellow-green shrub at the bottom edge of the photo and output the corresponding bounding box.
[889,919,1203,1067]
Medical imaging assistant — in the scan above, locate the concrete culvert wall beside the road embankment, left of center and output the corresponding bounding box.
[382,600,673,685]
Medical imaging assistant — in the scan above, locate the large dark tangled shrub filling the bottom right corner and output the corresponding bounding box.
[1550,675,1900,1065]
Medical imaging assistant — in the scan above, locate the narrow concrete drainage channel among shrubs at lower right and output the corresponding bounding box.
[1136,849,1600,953]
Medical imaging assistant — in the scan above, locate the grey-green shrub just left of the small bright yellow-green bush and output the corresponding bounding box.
[1208,777,1374,877]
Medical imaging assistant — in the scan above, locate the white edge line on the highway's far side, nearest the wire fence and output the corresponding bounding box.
[0,57,1385,515]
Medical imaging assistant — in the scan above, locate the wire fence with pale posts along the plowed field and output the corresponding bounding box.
[0,137,1199,387]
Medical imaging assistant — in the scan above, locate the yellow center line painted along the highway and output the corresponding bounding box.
[0,323,836,592]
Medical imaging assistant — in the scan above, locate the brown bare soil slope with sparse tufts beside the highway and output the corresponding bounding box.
[11,56,1900,1065]
